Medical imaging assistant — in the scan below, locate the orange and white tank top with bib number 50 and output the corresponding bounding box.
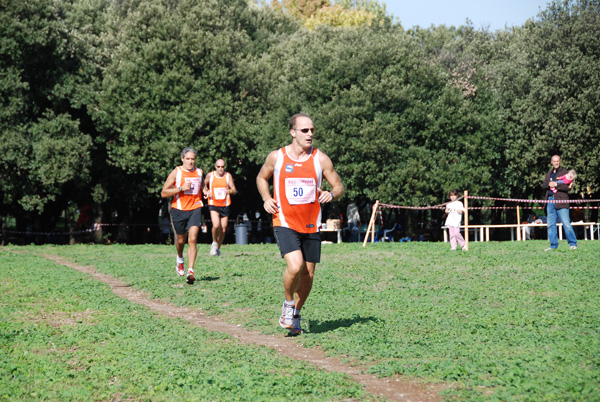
[273,147,323,233]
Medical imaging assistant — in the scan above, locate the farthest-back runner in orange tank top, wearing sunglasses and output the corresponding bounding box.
[204,159,237,257]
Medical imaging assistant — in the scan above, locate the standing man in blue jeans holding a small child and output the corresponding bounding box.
[542,155,577,251]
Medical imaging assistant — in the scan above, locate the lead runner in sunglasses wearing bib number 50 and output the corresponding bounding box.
[256,113,344,335]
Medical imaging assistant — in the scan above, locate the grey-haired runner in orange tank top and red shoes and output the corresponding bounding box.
[160,148,204,285]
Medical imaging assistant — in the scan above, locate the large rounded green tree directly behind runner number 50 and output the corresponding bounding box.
[243,27,492,209]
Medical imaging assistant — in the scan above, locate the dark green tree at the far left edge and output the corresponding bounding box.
[0,0,92,229]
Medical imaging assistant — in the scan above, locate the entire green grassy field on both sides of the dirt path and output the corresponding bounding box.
[0,240,600,401]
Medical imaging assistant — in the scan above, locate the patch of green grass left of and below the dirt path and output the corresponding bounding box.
[0,251,372,402]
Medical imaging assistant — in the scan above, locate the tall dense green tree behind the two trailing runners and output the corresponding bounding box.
[92,0,297,228]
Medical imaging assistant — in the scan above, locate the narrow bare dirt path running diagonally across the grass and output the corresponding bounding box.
[43,254,447,402]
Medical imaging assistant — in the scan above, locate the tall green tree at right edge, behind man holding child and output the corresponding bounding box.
[493,0,600,198]
